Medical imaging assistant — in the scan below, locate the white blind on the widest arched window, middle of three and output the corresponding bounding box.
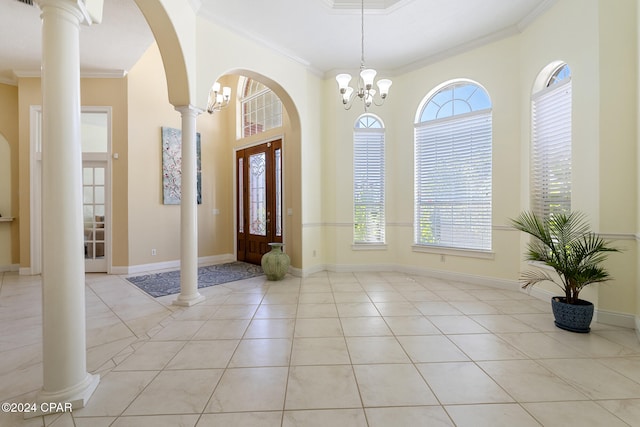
[415,110,492,250]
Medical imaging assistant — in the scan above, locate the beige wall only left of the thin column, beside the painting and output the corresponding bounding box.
[126,44,181,266]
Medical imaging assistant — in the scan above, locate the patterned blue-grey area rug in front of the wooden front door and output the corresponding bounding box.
[127,261,264,298]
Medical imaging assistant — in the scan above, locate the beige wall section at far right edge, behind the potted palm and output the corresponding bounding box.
[598,0,640,314]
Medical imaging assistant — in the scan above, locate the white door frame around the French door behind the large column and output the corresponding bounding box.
[29,105,113,275]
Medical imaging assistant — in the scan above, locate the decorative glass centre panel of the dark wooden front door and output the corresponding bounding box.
[249,153,267,236]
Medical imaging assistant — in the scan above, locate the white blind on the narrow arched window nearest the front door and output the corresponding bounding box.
[353,128,385,244]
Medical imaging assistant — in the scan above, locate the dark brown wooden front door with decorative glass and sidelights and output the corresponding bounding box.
[236,140,282,264]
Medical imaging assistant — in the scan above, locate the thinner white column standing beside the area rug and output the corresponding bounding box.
[173,105,205,306]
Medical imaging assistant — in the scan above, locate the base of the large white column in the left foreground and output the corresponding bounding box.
[24,374,100,419]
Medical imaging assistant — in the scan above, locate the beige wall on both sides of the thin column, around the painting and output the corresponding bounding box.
[124,44,234,267]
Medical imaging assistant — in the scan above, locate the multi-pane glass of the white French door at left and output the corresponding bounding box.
[82,166,105,259]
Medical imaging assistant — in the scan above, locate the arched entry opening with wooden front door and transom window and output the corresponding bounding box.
[205,69,302,267]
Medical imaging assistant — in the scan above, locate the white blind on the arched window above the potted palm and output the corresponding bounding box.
[531,79,571,222]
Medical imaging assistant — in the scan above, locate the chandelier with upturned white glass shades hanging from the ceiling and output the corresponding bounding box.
[336,0,391,111]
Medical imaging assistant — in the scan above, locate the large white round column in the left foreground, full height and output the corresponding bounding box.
[37,0,100,412]
